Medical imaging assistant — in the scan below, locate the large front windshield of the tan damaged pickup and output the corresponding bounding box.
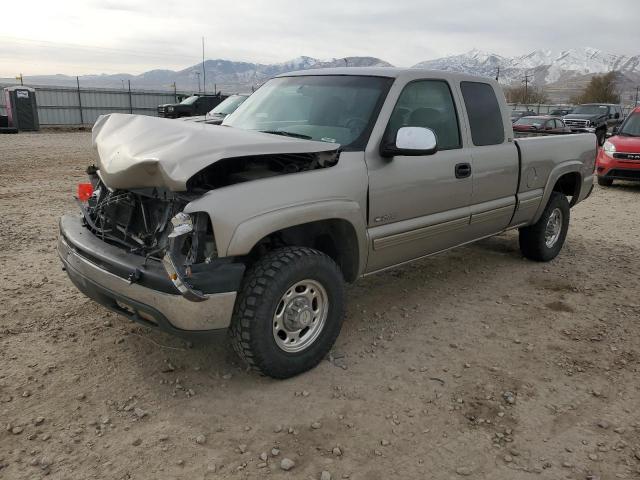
[223,75,393,150]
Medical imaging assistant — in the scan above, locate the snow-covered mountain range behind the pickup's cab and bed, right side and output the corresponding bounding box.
[414,47,640,84]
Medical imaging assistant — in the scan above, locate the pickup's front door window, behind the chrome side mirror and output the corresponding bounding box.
[387,80,462,150]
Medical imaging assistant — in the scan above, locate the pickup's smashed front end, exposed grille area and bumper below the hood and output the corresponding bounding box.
[58,167,245,334]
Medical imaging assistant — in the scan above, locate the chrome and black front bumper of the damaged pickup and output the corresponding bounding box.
[58,215,244,336]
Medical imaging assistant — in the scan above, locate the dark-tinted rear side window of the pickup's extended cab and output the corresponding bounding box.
[460,82,504,146]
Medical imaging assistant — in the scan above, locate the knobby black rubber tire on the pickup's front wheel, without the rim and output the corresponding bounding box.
[229,247,345,378]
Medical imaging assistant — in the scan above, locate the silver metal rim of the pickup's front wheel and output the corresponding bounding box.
[273,279,329,353]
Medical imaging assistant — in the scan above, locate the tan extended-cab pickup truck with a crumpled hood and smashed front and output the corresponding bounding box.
[58,68,596,378]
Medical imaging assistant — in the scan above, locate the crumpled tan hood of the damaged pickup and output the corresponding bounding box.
[92,113,340,191]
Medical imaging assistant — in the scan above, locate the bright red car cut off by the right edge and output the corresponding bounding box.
[596,107,640,187]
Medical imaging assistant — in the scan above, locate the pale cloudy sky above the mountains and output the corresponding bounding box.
[0,0,640,77]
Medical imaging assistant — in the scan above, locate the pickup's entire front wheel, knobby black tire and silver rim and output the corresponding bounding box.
[230,247,344,378]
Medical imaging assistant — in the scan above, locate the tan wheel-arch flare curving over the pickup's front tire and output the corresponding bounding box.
[226,199,368,275]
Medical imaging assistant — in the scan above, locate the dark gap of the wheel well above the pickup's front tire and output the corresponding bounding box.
[248,218,360,282]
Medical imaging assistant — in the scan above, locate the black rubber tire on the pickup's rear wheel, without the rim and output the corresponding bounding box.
[520,192,570,262]
